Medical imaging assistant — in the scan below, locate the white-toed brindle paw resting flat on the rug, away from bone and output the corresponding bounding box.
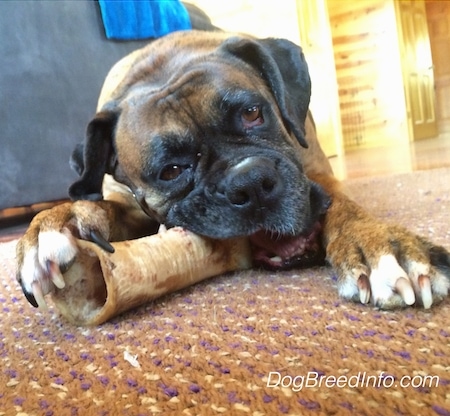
[327,202,450,309]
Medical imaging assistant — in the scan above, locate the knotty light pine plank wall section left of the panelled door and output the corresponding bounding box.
[328,0,408,149]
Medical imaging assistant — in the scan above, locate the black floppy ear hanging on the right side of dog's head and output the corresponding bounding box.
[223,37,311,147]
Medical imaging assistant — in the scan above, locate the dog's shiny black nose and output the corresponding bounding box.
[221,157,282,210]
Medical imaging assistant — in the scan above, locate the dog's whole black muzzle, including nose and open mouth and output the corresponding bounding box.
[166,155,330,269]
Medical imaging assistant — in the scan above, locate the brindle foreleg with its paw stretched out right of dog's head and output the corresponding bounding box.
[303,113,450,309]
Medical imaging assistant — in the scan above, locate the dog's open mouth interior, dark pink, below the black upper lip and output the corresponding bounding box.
[250,222,325,269]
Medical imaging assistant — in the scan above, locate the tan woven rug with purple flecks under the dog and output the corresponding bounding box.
[0,169,450,416]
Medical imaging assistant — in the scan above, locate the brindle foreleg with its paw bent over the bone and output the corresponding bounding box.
[16,184,158,307]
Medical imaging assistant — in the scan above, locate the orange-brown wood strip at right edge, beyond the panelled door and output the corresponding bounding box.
[425,0,450,133]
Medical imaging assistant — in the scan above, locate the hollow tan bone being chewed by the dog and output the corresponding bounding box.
[52,227,251,326]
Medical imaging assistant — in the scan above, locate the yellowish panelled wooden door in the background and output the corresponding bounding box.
[395,0,438,140]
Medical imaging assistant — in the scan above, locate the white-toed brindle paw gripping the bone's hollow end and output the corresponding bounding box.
[16,201,113,308]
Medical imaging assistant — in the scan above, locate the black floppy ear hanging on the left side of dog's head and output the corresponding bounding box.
[69,111,118,201]
